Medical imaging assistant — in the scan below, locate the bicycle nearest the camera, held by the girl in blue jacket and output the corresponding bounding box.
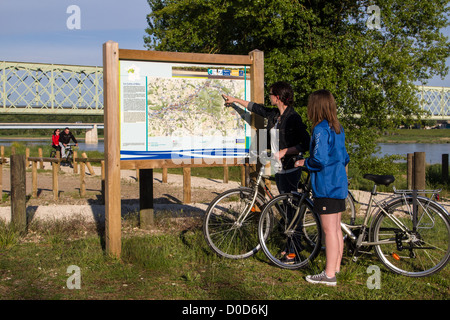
[258,169,450,277]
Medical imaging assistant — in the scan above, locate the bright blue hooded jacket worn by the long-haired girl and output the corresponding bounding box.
[305,120,350,199]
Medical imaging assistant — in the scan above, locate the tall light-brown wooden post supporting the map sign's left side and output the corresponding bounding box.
[103,41,122,257]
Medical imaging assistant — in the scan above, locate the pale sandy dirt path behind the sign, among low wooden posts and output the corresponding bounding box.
[0,164,253,221]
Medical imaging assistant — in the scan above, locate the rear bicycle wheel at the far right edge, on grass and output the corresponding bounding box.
[372,197,450,277]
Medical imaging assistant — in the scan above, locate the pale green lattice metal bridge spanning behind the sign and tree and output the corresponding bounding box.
[0,61,450,120]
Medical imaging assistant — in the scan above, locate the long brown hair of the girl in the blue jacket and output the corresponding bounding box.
[308,89,341,134]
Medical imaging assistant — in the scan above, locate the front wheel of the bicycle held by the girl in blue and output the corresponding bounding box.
[258,193,322,269]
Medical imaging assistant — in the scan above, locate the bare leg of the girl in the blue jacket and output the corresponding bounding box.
[320,213,344,278]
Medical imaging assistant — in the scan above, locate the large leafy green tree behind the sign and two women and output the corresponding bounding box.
[144,0,450,174]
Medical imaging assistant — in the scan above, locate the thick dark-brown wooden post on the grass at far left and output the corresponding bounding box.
[10,154,27,232]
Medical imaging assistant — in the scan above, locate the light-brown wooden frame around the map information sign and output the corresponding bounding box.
[103,40,264,257]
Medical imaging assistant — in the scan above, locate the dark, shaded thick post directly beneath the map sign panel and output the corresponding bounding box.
[139,169,154,229]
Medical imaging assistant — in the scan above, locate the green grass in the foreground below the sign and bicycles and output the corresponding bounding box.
[0,214,450,301]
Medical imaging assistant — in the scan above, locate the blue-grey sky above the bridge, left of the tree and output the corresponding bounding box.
[0,0,450,87]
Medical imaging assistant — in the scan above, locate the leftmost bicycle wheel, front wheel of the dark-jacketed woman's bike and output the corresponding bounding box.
[203,188,264,259]
